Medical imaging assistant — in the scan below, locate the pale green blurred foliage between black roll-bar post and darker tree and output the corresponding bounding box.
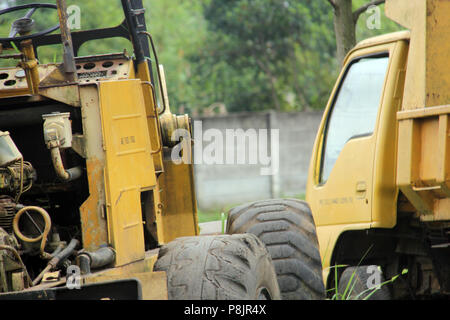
[144,0,207,112]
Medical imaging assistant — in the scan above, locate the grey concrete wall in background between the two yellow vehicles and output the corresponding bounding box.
[194,112,322,210]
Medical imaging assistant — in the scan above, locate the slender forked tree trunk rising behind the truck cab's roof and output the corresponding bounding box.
[333,0,356,65]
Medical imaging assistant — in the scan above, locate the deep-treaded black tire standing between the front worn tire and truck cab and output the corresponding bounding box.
[227,199,325,300]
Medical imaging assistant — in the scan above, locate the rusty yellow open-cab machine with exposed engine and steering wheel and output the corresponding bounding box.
[0,0,280,299]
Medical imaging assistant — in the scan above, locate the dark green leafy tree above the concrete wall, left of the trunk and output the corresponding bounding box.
[190,0,334,111]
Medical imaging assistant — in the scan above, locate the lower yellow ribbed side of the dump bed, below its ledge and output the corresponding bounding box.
[397,111,450,221]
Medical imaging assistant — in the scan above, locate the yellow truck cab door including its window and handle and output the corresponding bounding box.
[307,45,390,226]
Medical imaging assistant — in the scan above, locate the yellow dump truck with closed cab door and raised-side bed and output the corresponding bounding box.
[306,0,450,299]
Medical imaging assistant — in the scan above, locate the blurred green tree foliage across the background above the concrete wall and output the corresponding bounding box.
[0,0,398,113]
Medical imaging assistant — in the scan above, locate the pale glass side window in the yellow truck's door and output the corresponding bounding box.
[320,56,389,184]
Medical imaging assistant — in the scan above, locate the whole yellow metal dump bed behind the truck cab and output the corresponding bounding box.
[386,0,450,221]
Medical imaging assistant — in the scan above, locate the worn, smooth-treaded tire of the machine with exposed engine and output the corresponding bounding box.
[154,235,281,300]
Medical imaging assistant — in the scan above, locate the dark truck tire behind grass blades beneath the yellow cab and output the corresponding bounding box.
[338,266,392,300]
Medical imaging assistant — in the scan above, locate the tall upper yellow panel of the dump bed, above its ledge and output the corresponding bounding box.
[386,0,450,110]
